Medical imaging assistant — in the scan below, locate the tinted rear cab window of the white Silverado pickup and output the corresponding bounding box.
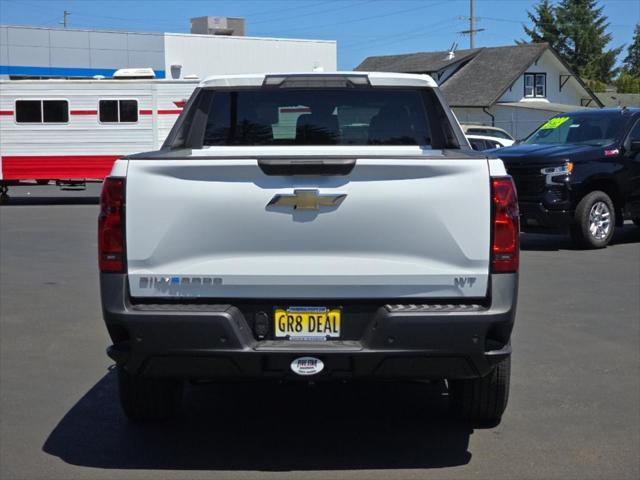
[166,88,457,148]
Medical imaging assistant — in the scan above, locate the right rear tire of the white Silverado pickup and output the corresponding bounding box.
[449,357,511,426]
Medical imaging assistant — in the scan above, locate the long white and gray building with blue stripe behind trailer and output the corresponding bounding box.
[0,25,337,79]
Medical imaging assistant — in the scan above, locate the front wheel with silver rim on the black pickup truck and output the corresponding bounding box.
[571,190,616,248]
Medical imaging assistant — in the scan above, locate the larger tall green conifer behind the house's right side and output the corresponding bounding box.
[525,0,622,83]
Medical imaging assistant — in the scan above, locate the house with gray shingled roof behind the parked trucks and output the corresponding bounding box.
[356,43,603,138]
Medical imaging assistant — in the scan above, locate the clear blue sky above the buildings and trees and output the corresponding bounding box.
[0,0,640,70]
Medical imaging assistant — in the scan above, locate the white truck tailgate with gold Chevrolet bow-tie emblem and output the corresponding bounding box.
[126,156,491,299]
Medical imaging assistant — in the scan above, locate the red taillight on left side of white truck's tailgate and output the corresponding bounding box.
[98,177,124,272]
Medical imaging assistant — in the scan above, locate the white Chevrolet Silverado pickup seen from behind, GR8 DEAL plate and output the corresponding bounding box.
[98,72,519,422]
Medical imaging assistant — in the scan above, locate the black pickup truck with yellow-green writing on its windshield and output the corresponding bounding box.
[493,108,640,248]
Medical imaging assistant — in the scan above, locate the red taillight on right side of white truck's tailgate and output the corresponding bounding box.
[491,177,520,273]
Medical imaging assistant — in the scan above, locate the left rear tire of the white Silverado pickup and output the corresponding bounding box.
[118,367,183,422]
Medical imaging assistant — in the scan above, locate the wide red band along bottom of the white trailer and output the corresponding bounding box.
[2,155,122,180]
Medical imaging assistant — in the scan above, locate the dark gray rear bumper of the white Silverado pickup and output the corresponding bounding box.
[100,274,518,380]
